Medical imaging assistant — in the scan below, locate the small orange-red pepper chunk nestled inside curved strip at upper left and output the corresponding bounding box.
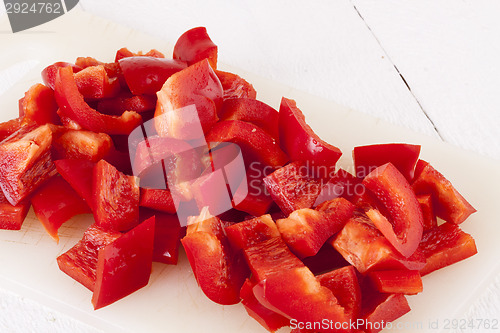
[75,65,121,100]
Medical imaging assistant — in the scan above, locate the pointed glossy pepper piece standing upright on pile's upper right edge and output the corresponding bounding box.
[279,97,342,167]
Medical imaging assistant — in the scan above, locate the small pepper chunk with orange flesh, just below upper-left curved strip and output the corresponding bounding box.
[52,129,113,162]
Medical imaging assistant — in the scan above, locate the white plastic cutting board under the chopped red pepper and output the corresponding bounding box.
[0,10,500,333]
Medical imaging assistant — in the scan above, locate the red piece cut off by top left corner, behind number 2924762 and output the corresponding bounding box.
[3,0,79,33]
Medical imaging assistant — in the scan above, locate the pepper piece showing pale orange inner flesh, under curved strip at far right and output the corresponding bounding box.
[331,217,425,274]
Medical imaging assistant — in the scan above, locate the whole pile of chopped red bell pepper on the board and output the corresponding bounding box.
[0,28,477,333]
